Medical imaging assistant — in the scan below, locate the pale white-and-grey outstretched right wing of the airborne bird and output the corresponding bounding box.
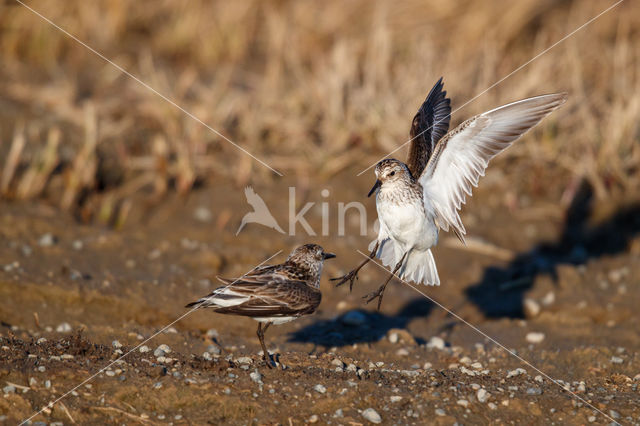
[419,93,567,243]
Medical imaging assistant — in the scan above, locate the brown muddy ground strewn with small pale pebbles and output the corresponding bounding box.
[0,172,640,425]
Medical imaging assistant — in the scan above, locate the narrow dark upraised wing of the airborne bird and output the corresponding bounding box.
[407,77,451,178]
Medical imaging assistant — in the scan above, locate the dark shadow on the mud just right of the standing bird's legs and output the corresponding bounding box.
[289,299,434,347]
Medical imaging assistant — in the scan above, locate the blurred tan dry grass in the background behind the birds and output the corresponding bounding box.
[0,0,640,224]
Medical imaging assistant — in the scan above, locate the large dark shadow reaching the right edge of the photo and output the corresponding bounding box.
[466,182,640,318]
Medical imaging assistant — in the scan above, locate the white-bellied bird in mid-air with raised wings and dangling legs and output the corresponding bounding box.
[332,78,567,309]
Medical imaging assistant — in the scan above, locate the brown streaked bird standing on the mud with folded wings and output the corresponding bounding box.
[186,244,336,368]
